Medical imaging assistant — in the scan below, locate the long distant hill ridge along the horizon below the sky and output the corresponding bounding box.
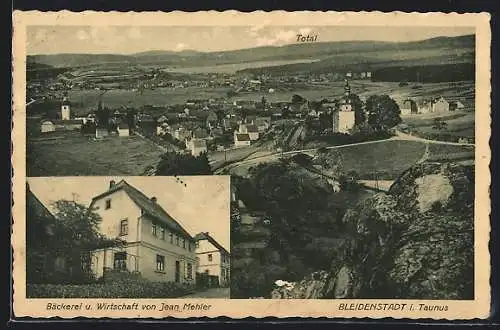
[28,35,475,67]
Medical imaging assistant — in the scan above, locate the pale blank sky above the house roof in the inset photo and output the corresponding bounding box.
[27,175,230,251]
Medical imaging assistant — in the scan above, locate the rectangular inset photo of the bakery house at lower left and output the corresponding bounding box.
[26,176,231,298]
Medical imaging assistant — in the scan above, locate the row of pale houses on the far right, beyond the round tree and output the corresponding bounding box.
[396,96,466,116]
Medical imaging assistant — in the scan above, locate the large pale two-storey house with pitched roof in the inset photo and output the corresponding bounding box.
[90,180,196,284]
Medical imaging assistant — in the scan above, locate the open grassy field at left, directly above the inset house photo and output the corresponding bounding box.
[27,133,163,176]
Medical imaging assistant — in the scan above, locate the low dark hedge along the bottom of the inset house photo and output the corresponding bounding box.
[26,277,193,298]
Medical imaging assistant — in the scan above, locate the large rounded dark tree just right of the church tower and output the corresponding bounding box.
[366,95,401,131]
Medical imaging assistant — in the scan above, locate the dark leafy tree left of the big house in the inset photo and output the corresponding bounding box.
[27,200,123,283]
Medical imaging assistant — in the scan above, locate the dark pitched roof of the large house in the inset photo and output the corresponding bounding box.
[90,180,192,239]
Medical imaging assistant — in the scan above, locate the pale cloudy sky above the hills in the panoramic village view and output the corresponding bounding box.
[27,22,475,55]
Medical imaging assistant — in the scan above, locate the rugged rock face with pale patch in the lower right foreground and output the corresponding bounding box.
[273,163,474,299]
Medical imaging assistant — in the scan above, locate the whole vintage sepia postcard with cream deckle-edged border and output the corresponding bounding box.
[12,11,491,320]
